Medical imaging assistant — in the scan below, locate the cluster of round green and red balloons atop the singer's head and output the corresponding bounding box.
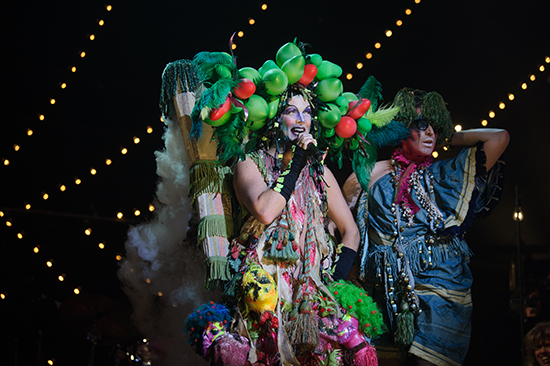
[193,41,397,166]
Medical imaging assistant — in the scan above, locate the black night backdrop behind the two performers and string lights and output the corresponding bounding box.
[0,0,550,365]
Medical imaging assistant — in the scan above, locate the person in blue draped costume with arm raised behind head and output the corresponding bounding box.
[344,88,509,366]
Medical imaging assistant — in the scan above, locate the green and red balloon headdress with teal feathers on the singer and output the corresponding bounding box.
[185,40,408,177]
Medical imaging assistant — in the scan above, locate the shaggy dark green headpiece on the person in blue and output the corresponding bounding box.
[394,88,453,145]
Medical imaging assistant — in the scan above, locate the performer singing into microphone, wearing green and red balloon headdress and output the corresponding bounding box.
[157,38,409,365]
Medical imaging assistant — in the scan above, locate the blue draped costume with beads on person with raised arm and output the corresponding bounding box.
[358,144,504,365]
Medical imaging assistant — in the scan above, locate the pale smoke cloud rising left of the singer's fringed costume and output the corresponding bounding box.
[118,119,219,366]
